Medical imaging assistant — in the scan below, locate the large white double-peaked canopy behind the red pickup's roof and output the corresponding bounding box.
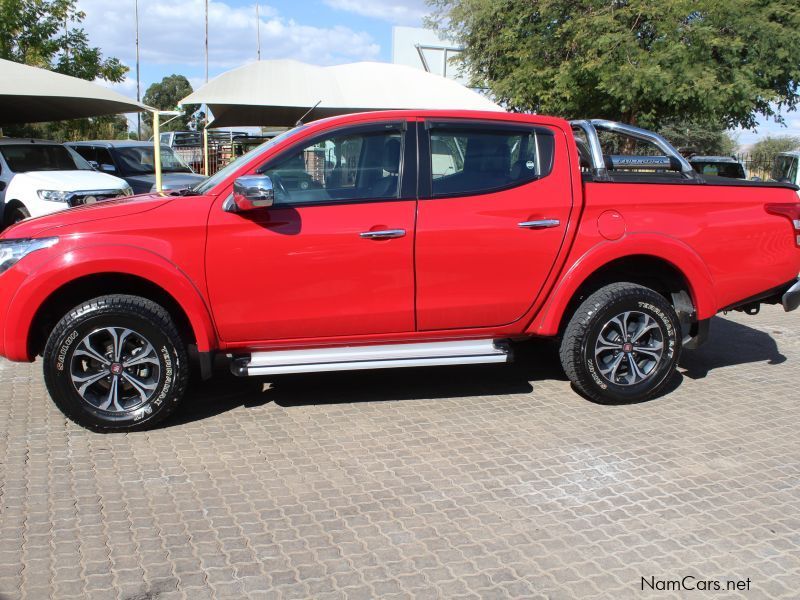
[181,60,503,127]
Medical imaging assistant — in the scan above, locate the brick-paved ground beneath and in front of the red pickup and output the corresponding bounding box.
[0,308,800,600]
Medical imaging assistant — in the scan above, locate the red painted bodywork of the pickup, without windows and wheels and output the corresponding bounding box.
[0,111,800,361]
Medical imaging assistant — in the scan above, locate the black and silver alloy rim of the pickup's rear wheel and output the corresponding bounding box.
[594,311,664,386]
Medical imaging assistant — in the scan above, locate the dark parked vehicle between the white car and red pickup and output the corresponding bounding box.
[68,140,205,194]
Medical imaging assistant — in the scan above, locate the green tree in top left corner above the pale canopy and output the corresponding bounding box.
[0,0,128,82]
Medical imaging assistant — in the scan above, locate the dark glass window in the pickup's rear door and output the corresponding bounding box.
[430,125,555,197]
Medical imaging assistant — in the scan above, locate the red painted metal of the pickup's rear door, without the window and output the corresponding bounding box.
[416,125,573,331]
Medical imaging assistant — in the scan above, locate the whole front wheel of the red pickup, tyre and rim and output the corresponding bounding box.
[44,295,189,432]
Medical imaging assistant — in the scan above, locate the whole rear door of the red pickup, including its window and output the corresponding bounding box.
[416,121,572,330]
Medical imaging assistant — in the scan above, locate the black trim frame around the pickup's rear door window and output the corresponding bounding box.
[417,119,556,200]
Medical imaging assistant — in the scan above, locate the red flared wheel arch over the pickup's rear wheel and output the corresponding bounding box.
[527,235,716,336]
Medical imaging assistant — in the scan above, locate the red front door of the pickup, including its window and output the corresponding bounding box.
[206,122,416,343]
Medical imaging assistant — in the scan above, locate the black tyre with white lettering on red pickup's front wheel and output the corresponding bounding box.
[44,294,189,432]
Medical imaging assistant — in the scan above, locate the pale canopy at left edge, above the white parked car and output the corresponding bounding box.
[0,59,151,125]
